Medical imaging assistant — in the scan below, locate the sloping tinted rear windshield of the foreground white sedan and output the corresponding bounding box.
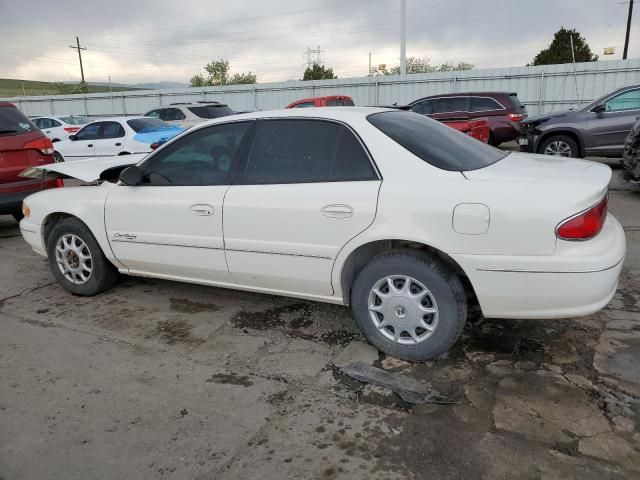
[367,111,507,171]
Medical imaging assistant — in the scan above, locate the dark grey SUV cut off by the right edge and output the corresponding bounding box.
[519,85,640,157]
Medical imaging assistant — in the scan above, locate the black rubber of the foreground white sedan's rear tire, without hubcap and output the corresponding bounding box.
[351,249,467,362]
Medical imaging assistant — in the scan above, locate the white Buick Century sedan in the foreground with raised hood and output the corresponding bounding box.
[20,107,625,361]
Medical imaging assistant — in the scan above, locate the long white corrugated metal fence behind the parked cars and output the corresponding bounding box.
[6,59,640,117]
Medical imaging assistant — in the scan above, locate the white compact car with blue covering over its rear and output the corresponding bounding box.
[53,117,183,162]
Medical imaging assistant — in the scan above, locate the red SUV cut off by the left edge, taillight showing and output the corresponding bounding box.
[0,102,60,220]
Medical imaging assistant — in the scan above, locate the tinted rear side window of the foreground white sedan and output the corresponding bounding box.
[244,119,376,185]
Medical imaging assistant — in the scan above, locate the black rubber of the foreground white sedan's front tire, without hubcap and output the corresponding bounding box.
[47,218,118,296]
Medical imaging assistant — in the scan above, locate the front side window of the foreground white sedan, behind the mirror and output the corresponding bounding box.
[141,121,254,185]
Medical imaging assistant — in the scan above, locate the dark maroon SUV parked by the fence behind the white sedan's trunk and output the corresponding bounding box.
[409,92,527,146]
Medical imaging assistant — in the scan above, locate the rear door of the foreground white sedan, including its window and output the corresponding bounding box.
[224,118,381,296]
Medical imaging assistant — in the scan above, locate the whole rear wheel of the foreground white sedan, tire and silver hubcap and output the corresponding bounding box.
[351,250,467,362]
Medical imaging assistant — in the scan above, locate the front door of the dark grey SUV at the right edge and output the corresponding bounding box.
[585,88,640,156]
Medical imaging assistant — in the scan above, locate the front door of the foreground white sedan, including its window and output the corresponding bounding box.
[105,121,254,284]
